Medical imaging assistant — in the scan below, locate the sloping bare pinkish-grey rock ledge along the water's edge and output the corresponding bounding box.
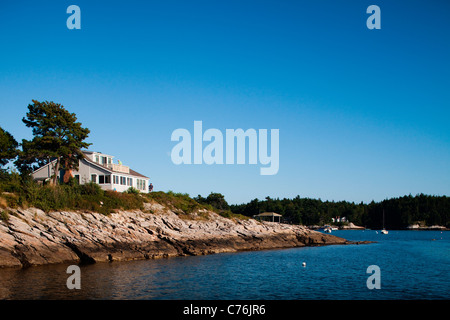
[0,203,370,267]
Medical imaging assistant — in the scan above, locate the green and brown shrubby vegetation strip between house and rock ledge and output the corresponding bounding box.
[0,173,247,220]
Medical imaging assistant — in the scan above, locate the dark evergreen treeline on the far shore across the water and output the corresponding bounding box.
[230,194,450,229]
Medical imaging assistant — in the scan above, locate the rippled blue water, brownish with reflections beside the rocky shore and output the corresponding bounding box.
[0,230,450,300]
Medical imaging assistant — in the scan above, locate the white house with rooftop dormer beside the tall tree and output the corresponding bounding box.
[31,151,149,193]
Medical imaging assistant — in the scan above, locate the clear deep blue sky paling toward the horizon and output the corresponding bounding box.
[0,0,450,203]
